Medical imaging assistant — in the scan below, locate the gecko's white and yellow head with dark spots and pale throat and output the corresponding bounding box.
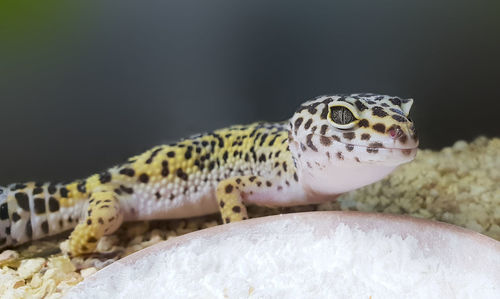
[289,94,418,193]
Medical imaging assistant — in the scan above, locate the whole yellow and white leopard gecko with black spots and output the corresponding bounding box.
[0,94,418,255]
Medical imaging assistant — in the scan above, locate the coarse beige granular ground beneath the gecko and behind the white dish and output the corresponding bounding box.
[0,137,500,298]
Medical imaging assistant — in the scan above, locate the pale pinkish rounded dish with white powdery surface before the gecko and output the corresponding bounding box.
[67,212,500,298]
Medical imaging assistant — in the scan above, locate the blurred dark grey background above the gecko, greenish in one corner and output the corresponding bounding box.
[0,0,500,185]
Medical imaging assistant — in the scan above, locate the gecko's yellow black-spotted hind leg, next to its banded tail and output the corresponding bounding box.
[69,188,123,256]
